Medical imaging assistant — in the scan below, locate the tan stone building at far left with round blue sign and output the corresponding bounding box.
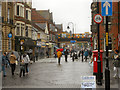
[0,2,15,52]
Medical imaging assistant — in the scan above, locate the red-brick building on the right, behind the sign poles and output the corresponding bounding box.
[91,2,120,51]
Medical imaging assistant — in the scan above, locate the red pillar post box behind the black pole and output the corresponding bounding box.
[93,50,103,78]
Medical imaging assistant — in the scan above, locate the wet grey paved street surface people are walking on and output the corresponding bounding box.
[2,56,120,88]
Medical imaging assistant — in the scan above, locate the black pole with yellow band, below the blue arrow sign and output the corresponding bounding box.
[105,16,110,90]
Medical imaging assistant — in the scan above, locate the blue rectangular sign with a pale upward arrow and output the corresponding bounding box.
[101,0,112,16]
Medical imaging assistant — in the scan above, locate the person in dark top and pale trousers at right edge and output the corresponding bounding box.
[113,50,120,78]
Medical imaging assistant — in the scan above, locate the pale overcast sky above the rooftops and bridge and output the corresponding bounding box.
[32,0,92,33]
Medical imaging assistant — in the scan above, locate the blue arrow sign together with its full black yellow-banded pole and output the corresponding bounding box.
[101,0,112,90]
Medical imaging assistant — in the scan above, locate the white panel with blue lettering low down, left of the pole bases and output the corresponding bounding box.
[81,76,96,88]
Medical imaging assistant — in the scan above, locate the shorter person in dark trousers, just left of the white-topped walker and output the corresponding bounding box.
[20,54,26,77]
